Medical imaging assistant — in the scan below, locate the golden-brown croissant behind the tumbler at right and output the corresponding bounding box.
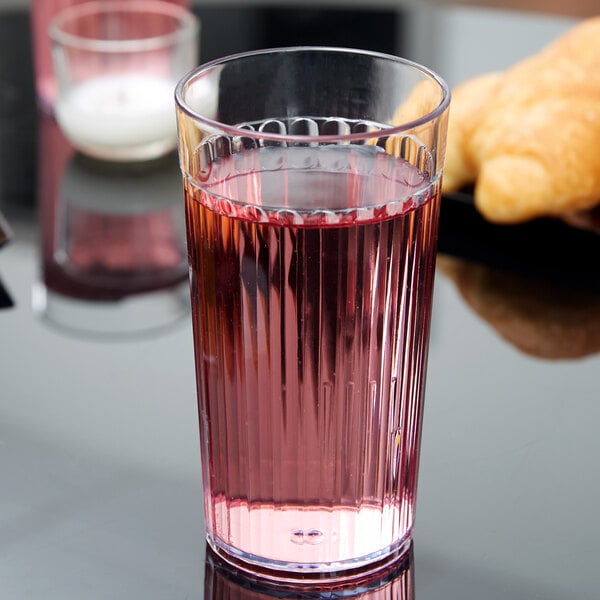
[444,17,600,223]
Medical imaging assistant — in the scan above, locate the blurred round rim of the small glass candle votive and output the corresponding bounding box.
[48,0,200,54]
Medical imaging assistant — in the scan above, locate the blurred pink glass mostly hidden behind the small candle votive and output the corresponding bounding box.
[31,0,191,114]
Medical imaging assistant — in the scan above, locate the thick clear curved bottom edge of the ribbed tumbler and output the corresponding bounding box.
[207,532,412,584]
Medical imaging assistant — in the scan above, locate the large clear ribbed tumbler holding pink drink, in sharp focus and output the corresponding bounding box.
[176,48,449,580]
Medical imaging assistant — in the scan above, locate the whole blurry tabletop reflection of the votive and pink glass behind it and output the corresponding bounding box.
[34,113,189,335]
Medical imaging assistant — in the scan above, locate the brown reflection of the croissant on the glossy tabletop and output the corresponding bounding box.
[438,256,600,359]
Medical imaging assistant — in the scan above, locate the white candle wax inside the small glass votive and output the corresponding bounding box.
[56,74,177,160]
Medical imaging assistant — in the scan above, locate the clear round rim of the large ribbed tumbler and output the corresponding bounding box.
[175,45,451,143]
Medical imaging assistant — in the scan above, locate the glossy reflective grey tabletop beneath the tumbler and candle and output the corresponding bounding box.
[0,2,600,600]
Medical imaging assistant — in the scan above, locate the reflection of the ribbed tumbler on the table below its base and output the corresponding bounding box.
[204,547,415,600]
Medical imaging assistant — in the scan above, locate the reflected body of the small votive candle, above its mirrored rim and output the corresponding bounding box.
[55,155,187,294]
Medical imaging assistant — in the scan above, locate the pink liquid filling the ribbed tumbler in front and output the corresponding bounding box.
[185,146,439,571]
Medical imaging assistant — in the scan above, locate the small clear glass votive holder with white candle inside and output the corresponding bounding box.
[49,0,199,161]
